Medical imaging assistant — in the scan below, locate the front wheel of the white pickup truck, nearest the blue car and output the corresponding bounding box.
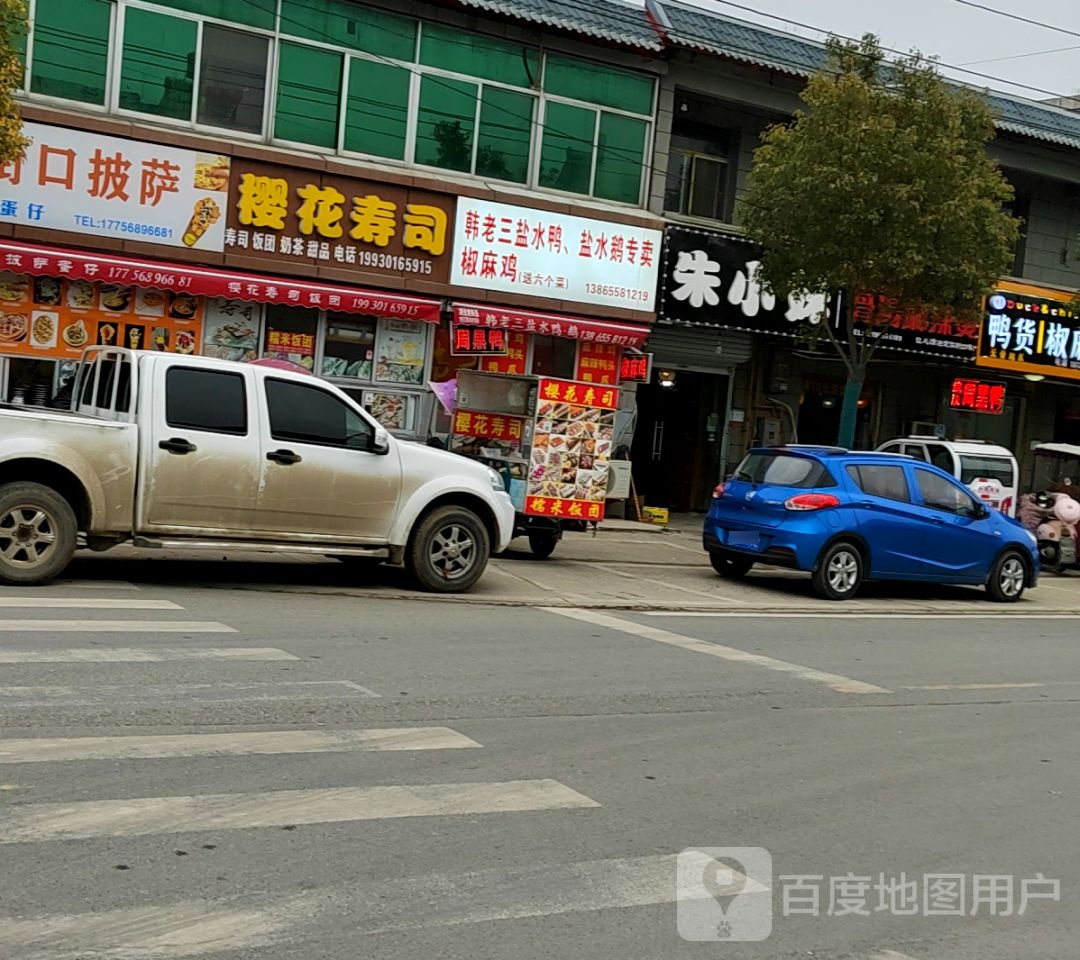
[405,505,491,593]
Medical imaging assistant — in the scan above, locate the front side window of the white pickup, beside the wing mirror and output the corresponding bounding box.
[266,378,375,450]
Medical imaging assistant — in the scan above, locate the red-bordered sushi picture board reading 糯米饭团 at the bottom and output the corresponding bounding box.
[525,379,619,520]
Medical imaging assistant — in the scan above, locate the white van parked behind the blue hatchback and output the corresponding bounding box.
[878,436,1020,516]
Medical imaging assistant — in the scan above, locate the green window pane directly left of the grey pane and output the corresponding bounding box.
[120,6,198,120]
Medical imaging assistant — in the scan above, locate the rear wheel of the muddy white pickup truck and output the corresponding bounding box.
[0,482,78,584]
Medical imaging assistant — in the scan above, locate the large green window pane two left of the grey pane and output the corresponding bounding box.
[30,0,110,104]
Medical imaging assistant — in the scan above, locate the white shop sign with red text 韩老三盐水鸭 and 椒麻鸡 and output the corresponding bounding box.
[450,198,663,312]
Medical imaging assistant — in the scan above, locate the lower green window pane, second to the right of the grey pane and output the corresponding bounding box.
[345,57,409,160]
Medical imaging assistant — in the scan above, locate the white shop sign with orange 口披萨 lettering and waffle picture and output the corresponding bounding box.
[0,122,230,252]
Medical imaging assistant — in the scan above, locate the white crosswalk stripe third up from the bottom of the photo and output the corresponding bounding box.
[0,727,481,763]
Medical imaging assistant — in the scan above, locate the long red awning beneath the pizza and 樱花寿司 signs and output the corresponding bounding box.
[0,240,442,323]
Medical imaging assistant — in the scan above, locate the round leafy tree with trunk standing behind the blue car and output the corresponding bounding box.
[743,33,1021,446]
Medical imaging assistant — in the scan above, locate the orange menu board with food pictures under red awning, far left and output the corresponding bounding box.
[0,271,203,359]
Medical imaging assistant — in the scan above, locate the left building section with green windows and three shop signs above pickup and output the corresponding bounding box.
[0,0,663,449]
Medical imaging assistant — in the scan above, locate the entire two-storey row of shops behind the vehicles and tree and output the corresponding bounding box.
[8,0,1080,510]
